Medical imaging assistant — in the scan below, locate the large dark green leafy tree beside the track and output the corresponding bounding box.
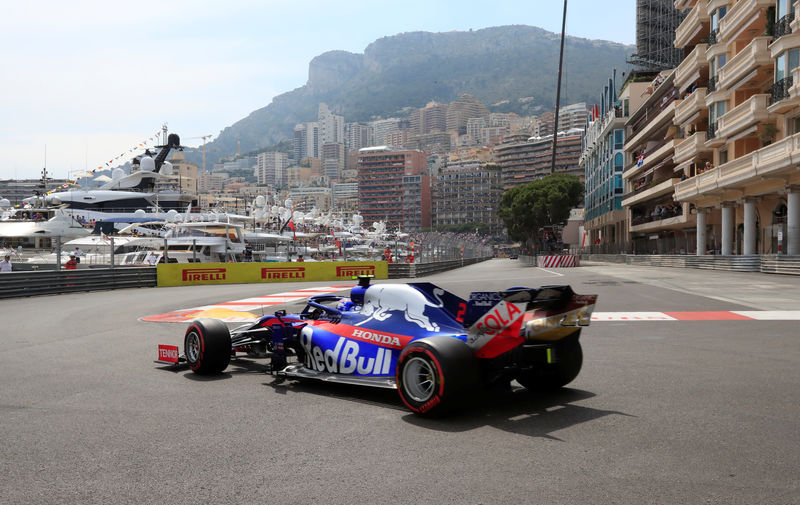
[498,174,583,248]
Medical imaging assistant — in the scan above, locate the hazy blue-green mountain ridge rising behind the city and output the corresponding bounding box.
[187,25,634,167]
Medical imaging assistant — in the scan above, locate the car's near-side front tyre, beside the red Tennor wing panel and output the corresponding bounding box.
[183,318,231,374]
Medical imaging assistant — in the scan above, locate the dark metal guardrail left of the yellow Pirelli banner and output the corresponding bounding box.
[0,267,156,298]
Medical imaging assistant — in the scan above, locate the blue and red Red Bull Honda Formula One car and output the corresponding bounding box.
[159,276,597,415]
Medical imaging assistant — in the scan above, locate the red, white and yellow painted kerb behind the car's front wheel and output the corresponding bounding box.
[141,284,353,323]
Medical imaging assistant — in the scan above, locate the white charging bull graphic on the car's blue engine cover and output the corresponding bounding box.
[356,285,442,331]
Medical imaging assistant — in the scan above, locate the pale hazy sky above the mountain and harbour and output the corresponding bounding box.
[0,0,636,181]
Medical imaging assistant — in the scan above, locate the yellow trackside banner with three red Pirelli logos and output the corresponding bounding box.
[158,261,389,286]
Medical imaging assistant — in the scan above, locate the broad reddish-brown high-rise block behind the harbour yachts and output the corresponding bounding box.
[358,146,430,227]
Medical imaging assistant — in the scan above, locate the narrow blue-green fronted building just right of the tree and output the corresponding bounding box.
[577,78,649,249]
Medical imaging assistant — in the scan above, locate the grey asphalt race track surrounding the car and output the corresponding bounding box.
[0,260,800,504]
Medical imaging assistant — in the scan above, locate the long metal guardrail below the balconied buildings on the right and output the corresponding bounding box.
[581,254,800,275]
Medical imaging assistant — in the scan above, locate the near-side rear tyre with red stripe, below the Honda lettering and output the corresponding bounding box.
[395,337,479,416]
